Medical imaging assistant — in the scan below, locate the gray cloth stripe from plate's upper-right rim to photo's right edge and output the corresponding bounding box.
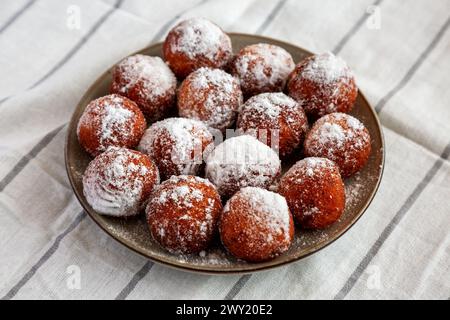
[375,16,450,113]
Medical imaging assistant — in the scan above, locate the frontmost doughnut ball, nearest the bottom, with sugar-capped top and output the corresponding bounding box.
[219,187,294,262]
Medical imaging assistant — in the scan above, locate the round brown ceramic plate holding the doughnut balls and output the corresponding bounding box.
[65,34,384,274]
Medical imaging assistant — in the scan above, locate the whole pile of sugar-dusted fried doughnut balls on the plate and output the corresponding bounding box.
[77,18,371,262]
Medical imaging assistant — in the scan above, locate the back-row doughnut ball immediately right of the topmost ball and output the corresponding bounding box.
[230,43,295,98]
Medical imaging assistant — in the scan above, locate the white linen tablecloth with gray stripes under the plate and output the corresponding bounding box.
[0,0,450,299]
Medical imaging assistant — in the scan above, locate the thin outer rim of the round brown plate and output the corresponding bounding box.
[64,32,386,275]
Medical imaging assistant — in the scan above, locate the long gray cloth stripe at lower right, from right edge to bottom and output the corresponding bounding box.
[334,143,450,299]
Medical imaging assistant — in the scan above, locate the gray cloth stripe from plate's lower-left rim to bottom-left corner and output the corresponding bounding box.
[1,210,86,300]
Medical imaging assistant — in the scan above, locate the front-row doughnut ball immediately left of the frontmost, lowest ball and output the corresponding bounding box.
[146,175,222,253]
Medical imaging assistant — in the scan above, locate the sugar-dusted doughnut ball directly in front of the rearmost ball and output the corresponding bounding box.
[178,68,243,131]
